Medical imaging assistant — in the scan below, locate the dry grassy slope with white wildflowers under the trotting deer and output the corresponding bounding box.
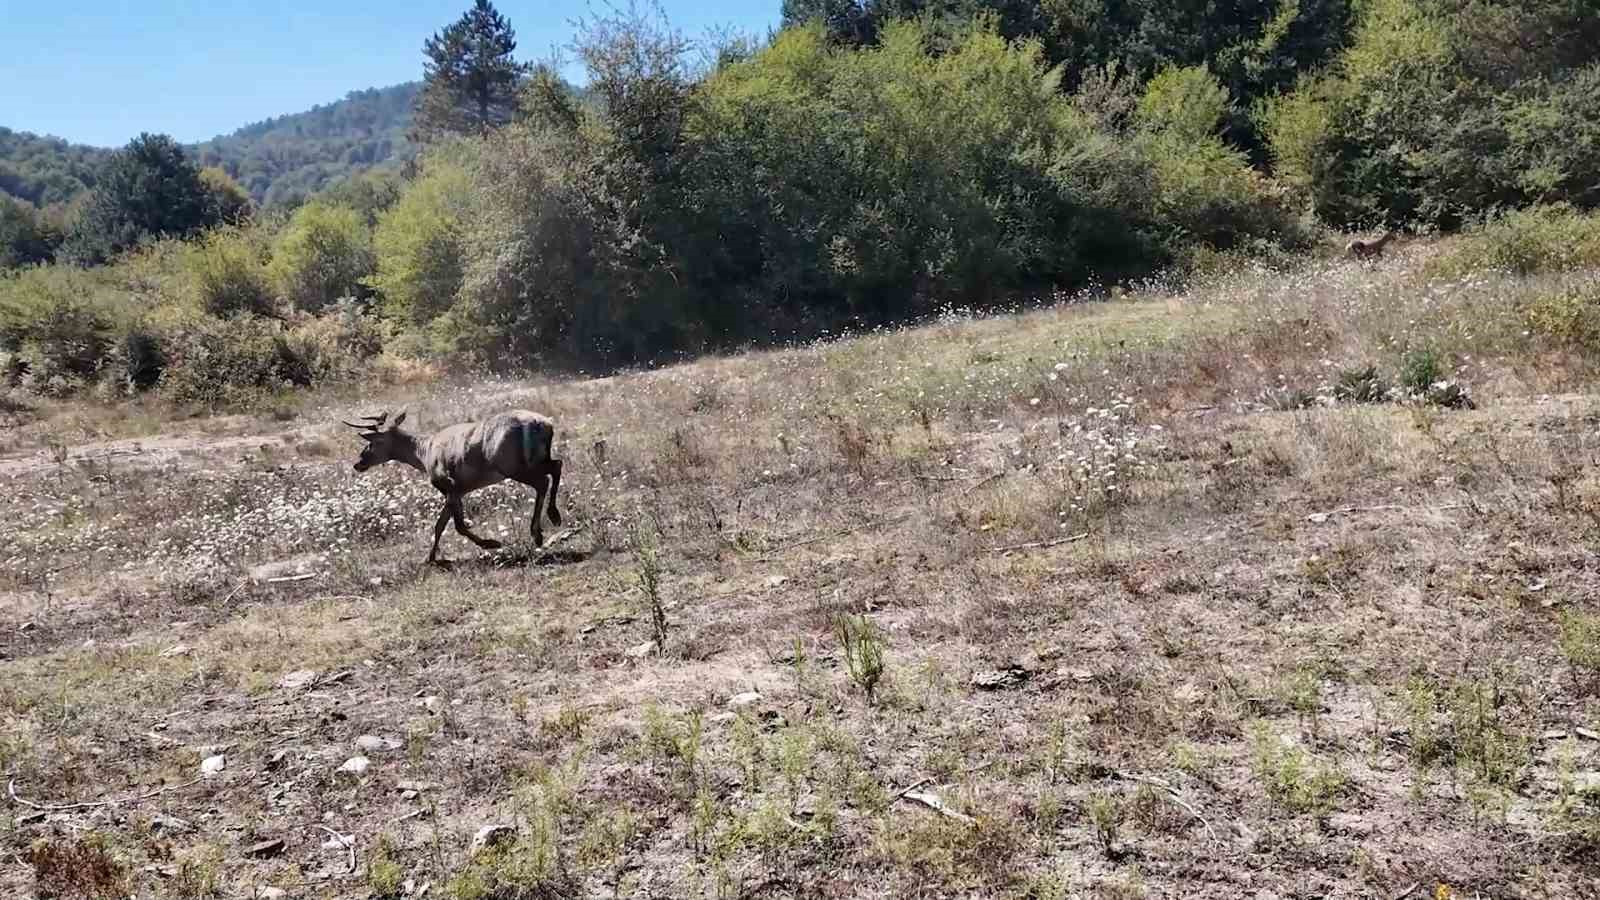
[0,240,1600,897]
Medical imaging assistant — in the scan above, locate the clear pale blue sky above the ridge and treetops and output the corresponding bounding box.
[0,0,779,147]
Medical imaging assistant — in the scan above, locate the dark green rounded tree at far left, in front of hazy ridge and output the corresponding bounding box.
[62,133,219,264]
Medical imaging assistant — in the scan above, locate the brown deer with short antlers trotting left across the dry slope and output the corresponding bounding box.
[344,410,562,564]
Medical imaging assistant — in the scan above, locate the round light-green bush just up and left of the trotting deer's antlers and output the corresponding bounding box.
[267,200,373,312]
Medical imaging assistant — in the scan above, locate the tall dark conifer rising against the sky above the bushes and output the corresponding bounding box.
[411,0,526,141]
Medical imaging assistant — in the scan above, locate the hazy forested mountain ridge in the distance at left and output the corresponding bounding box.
[0,82,422,207]
